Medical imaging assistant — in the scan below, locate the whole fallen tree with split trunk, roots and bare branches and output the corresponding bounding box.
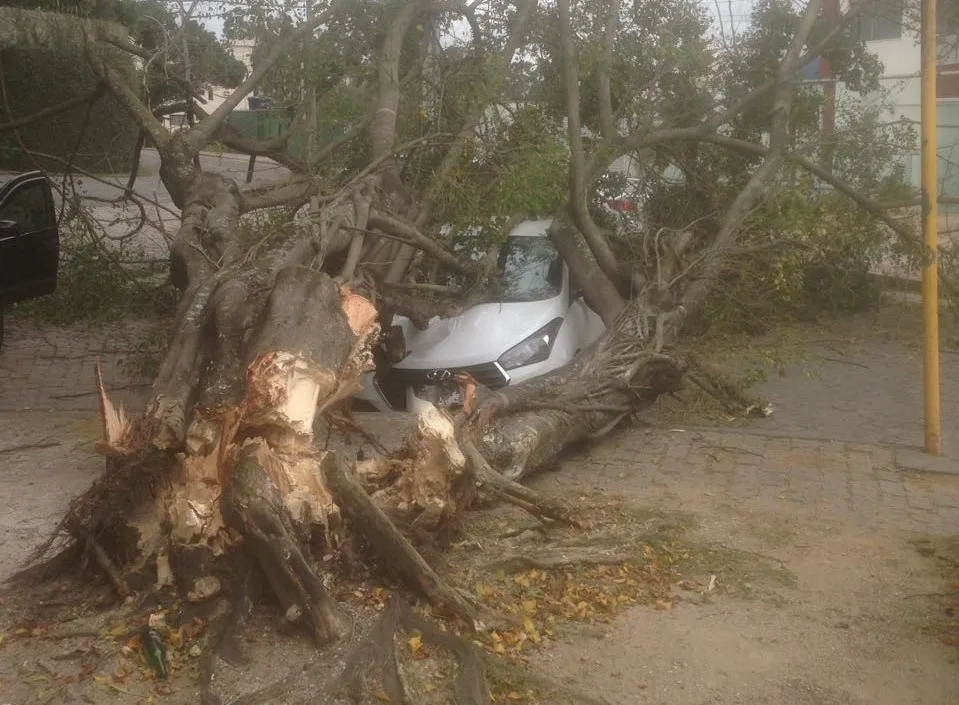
[3,0,928,704]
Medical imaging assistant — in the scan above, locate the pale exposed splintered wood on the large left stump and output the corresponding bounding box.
[83,287,379,598]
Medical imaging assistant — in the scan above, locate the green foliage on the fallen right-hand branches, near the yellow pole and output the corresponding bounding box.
[620,0,916,332]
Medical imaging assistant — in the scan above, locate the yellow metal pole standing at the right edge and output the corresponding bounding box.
[921,0,942,455]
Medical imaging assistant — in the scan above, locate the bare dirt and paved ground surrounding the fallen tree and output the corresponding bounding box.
[0,298,959,705]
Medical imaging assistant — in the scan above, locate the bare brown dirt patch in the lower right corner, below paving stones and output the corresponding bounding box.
[536,440,959,705]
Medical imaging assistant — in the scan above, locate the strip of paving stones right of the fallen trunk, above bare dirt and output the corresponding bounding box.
[552,429,959,536]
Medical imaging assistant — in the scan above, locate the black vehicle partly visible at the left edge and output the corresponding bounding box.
[0,171,60,345]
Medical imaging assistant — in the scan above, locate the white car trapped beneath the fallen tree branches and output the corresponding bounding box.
[357,220,606,412]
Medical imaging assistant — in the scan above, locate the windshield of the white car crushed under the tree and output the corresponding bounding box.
[497,237,563,303]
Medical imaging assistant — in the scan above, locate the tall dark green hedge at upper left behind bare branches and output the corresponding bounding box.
[0,43,137,173]
